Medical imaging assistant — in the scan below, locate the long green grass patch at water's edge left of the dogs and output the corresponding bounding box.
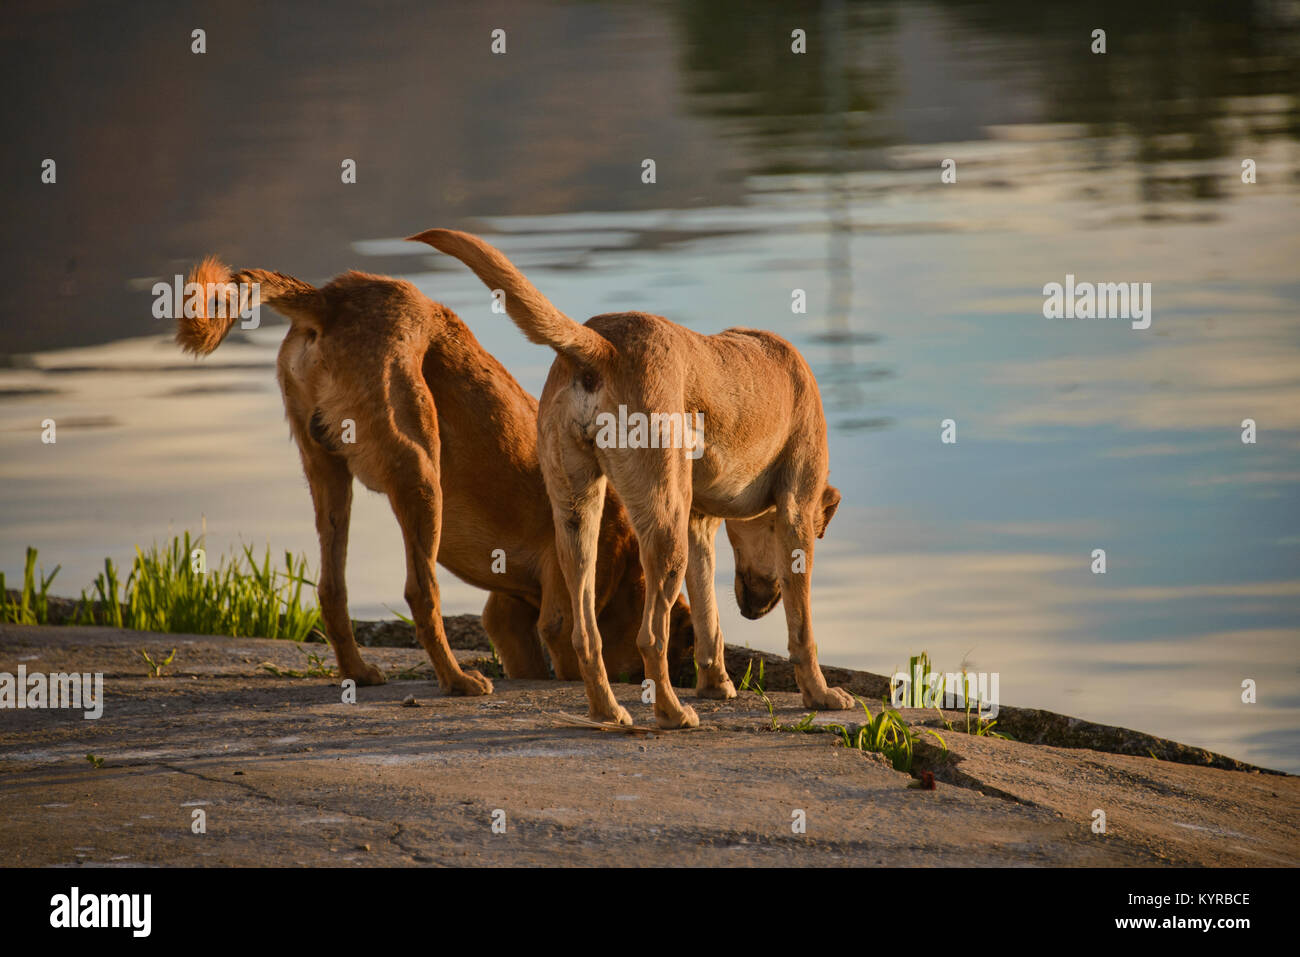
[0,532,321,641]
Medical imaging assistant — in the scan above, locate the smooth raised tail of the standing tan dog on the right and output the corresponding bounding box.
[408,229,614,368]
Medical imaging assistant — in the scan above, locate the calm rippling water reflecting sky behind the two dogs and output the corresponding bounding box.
[0,3,1300,771]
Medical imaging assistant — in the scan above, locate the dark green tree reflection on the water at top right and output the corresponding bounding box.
[675,0,1300,170]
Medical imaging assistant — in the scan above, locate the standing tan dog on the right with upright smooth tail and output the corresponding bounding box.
[411,229,853,728]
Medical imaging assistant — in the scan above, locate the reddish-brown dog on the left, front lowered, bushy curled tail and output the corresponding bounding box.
[177,259,692,694]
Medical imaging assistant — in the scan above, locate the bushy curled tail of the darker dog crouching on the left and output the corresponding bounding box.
[176,256,325,355]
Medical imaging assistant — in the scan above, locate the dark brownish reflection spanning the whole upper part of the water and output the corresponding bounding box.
[0,0,1300,352]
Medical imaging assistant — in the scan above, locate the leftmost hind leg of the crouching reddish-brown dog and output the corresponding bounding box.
[295,428,385,685]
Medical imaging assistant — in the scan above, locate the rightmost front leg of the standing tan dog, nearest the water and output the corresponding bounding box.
[776,502,854,711]
